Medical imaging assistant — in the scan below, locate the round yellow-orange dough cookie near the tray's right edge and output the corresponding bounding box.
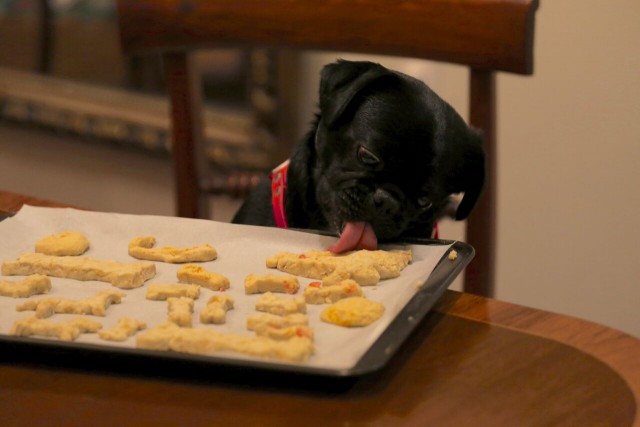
[320,297,384,326]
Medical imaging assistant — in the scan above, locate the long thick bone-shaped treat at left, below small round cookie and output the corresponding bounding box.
[2,253,156,289]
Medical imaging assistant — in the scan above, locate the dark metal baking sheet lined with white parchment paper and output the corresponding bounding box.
[0,206,473,375]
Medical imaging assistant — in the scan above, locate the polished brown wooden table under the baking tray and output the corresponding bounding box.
[0,192,640,426]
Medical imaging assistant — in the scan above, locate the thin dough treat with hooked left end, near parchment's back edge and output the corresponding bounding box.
[129,236,218,263]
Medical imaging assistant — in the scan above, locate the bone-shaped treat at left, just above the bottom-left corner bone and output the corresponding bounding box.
[16,290,127,318]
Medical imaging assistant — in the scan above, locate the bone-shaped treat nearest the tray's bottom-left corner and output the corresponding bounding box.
[9,317,102,341]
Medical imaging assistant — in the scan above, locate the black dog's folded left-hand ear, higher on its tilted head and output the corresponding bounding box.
[320,60,393,128]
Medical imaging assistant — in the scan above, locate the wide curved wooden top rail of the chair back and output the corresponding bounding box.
[118,0,538,74]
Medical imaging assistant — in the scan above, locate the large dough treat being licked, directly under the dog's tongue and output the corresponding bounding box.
[266,250,412,286]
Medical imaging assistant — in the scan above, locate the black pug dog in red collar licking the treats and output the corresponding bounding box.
[233,60,485,253]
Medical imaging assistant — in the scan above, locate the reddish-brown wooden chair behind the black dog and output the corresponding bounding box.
[118,0,538,296]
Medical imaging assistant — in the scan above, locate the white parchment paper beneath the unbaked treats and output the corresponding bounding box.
[0,206,449,370]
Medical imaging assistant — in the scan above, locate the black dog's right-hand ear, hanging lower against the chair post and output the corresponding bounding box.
[442,128,486,221]
